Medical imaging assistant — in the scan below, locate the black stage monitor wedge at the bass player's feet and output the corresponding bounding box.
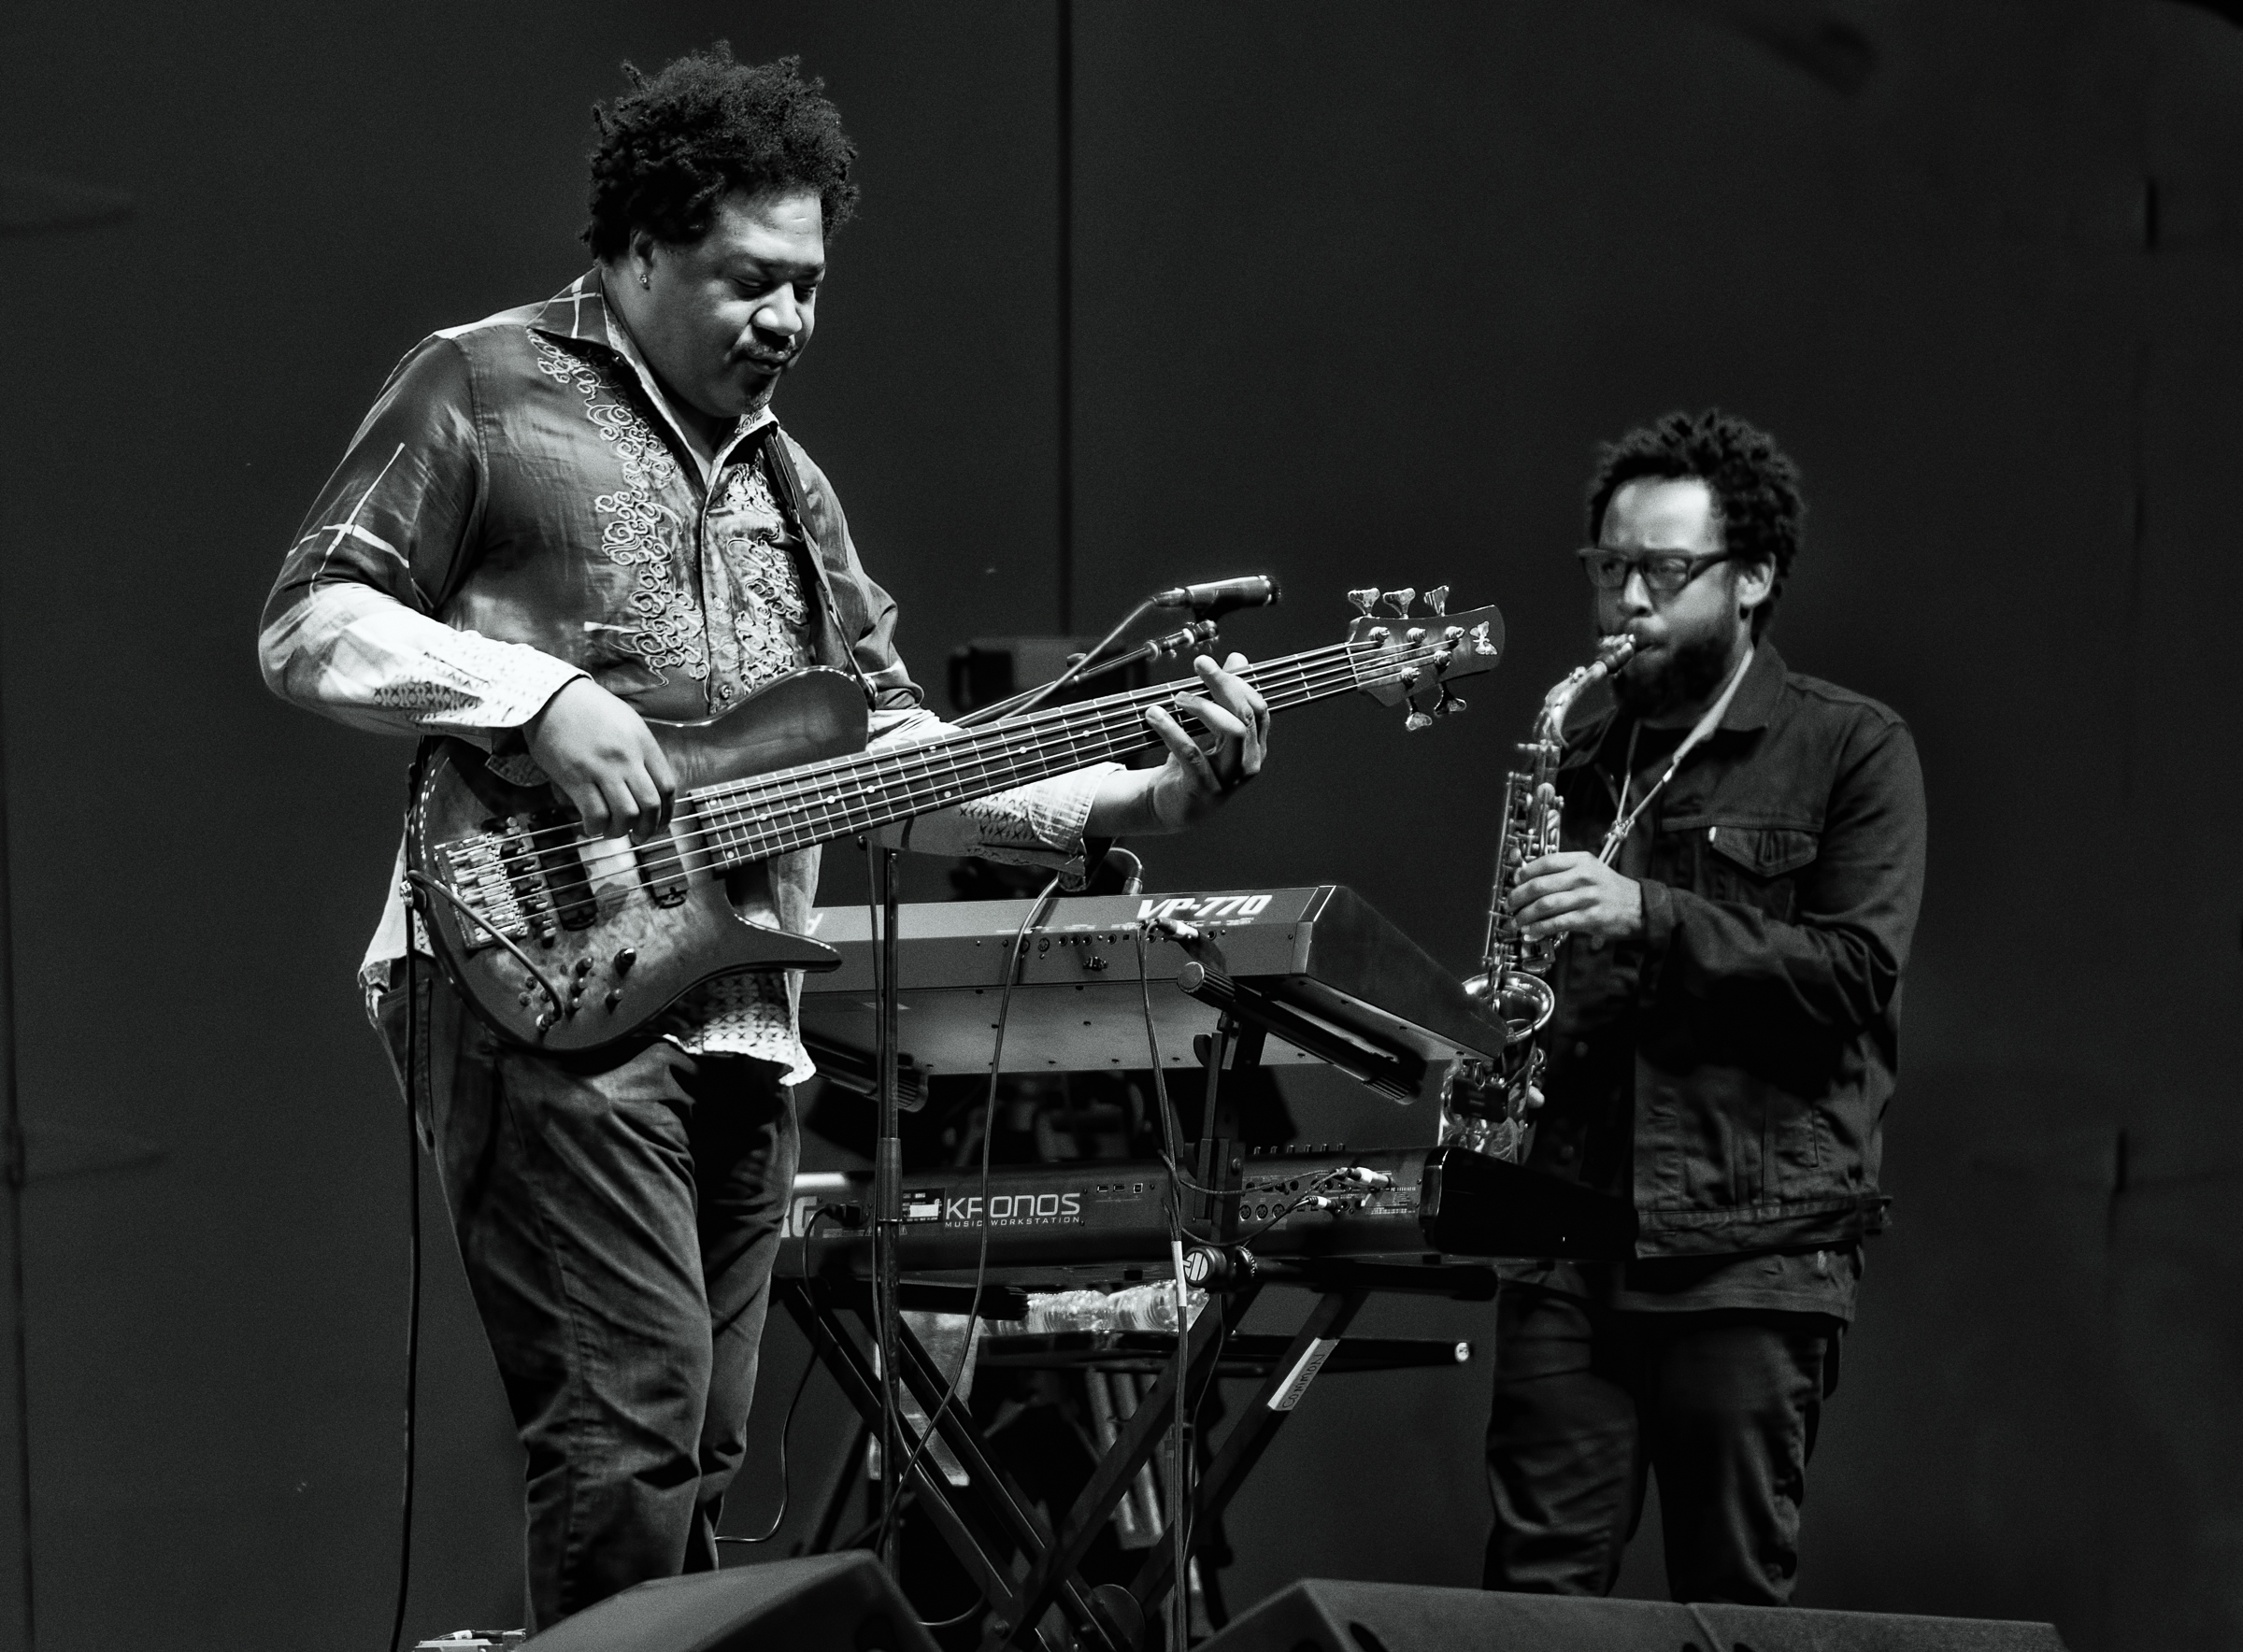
[522,1553,936,1652]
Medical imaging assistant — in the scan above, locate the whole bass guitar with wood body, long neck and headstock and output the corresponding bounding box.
[406,588,1503,1053]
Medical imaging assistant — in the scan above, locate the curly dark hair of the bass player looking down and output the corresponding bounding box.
[583,40,857,260]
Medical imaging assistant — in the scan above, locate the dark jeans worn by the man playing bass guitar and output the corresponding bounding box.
[375,960,798,1630]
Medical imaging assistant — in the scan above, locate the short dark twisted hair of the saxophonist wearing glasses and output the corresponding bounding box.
[1588,408,1807,639]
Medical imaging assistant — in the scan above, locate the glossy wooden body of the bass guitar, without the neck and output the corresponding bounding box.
[406,668,868,1053]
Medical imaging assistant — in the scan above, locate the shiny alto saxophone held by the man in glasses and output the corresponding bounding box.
[1440,632,1636,1163]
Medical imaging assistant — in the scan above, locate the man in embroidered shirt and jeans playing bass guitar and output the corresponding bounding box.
[260,45,1269,1628]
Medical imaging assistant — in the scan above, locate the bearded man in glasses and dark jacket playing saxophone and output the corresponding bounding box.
[1485,412,1924,1605]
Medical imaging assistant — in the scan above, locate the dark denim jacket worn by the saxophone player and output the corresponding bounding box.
[1530,641,1924,1258]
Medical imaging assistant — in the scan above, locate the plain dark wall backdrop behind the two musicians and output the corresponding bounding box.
[0,0,2243,1650]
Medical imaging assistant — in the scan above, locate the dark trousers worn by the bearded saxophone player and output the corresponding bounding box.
[1482,1285,1839,1605]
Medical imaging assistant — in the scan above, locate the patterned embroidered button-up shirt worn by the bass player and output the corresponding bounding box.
[258,269,1112,1083]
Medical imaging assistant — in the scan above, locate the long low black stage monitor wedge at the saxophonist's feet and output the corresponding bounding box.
[1200,1578,2064,1652]
